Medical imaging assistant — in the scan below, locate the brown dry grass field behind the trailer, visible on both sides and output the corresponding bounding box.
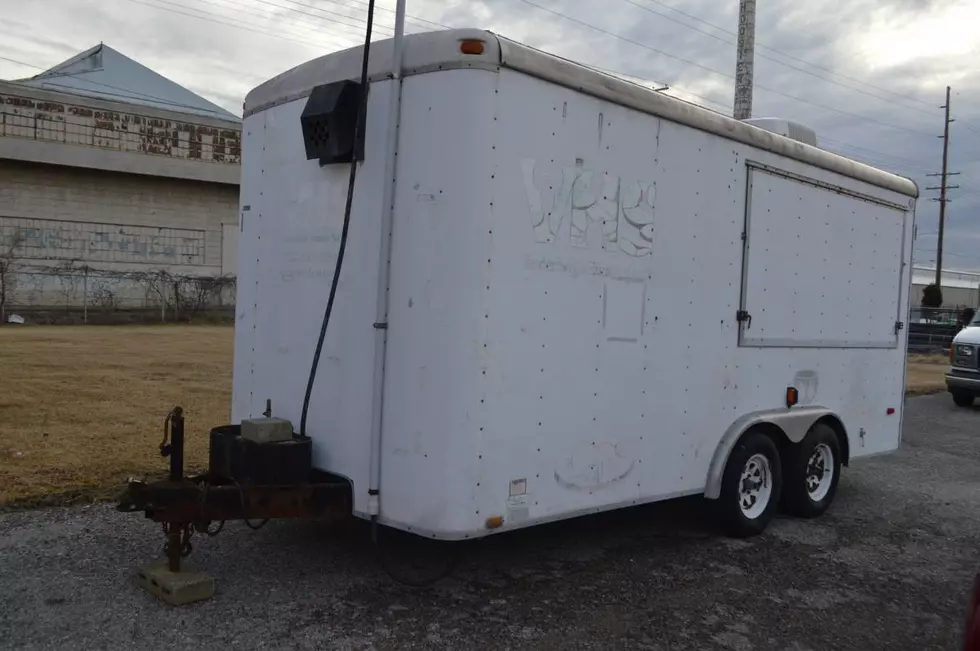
[0,325,946,506]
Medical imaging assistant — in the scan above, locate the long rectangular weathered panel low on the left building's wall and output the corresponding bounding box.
[0,217,205,265]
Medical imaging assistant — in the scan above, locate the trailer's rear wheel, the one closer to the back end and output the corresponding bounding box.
[783,423,841,518]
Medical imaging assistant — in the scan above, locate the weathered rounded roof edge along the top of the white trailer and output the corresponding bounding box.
[245,29,919,197]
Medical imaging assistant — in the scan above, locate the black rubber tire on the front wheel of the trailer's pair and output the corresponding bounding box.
[717,431,783,538]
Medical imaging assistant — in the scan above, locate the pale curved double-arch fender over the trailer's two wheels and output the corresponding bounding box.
[704,405,850,500]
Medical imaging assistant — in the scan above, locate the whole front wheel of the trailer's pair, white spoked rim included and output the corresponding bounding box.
[718,431,783,538]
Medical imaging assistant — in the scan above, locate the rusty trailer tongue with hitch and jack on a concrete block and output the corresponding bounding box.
[117,407,351,605]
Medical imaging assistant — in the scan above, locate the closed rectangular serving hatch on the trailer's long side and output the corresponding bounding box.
[739,163,912,348]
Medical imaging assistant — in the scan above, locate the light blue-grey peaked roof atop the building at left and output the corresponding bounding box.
[14,44,241,122]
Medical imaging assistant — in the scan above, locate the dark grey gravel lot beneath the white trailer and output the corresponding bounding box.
[0,395,980,651]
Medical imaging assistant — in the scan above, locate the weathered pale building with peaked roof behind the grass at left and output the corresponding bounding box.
[0,45,241,312]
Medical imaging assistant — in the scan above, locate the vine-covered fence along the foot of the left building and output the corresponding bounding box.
[0,260,235,323]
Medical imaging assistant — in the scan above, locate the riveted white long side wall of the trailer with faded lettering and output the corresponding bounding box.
[365,68,913,538]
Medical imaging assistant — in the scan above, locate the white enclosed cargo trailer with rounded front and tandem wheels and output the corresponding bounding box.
[232,30,917,540]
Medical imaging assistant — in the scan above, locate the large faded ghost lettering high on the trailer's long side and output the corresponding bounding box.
[521,159,656,257]
